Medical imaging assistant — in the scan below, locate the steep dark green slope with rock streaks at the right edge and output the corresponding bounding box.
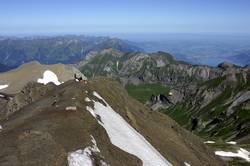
[165,67,250,140]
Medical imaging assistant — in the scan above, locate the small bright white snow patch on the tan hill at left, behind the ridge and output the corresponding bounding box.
[37,70,61,85]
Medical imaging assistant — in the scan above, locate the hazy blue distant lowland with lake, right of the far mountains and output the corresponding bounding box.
[131,34,250,66]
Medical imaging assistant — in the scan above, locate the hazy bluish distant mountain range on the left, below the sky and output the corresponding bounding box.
[0,35,142,68]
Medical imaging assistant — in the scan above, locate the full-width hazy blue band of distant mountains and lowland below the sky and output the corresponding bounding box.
[0,35,250,72]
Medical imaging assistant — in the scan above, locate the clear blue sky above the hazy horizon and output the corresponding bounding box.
[0,0,250,34]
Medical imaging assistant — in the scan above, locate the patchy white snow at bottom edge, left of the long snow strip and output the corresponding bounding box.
[67,135,107,166]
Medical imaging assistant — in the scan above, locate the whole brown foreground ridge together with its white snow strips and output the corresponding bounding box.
[0,78,224,166]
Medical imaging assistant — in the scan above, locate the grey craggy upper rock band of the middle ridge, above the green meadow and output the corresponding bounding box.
[78,49,224,86]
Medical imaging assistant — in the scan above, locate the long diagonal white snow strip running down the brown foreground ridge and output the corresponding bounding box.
[87,92,172,166]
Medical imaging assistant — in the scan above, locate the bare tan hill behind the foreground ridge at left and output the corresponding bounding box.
[0,61,85,94]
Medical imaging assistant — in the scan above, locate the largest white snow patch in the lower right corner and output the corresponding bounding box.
[215,148,250,162]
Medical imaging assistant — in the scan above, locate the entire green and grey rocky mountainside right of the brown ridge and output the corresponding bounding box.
[78,49,250,163]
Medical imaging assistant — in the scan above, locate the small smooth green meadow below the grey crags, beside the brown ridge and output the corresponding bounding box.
[125,83,169,103]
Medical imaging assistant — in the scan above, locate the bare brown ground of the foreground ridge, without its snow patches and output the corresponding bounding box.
[0,78,225,166]
